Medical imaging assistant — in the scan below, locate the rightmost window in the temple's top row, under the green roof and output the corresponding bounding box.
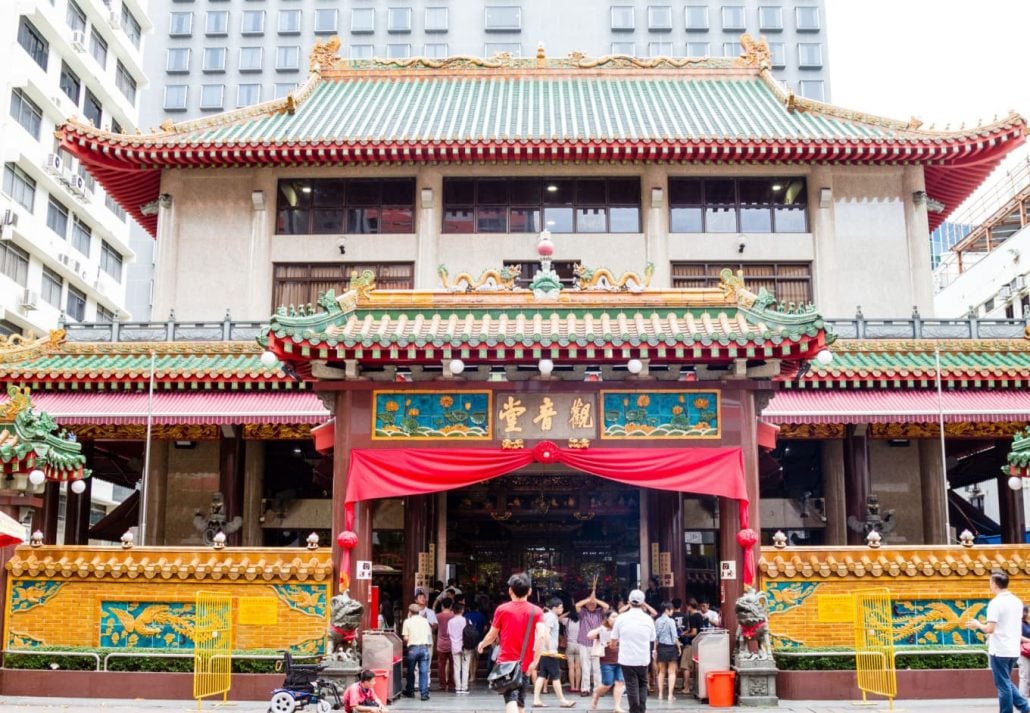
[668,176,808,233]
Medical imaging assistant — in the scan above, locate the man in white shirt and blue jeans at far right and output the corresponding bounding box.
[966,571,1030,713]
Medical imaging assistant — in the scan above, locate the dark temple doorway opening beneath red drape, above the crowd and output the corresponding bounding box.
[447,471,641,601]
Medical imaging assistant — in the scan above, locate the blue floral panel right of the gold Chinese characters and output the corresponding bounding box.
[600,392,720,440]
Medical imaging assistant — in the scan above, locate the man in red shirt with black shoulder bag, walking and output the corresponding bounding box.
[476,573,547,713]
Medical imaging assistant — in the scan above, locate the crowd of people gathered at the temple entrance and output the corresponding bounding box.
[379,574,720,713]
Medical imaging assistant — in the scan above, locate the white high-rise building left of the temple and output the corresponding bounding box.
[0,0,150,334]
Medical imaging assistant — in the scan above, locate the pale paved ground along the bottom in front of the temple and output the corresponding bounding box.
[0,691,998,713]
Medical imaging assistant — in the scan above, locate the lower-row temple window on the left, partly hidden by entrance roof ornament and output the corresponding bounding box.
[272,263,415,309]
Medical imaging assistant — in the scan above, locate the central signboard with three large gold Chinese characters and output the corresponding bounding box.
[493,394,597,440]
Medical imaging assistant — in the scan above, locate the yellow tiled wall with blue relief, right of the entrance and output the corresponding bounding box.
[759,545,1030,651]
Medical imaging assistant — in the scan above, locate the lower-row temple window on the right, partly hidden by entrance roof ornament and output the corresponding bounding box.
[672,263,812,304]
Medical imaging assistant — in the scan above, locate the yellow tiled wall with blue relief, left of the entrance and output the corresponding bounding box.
[3,547,333,653]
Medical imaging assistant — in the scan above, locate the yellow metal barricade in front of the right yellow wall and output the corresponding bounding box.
[855,588,898,710]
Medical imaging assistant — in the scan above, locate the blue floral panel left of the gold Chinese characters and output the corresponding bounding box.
[372,392,491,441]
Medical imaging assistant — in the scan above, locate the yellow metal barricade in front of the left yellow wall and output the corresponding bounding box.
[194,591,233,708]
